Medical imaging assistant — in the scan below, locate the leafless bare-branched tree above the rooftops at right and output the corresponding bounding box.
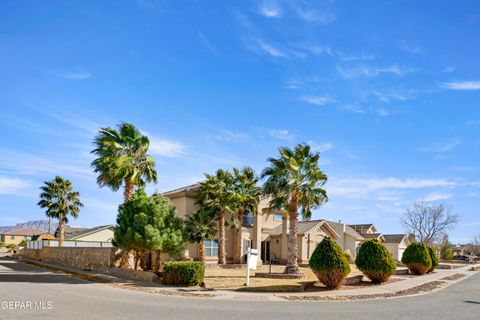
[402,200,458,243]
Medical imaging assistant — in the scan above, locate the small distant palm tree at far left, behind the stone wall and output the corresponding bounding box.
[38,176,83,246]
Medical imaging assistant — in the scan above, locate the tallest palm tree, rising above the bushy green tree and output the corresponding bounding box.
[92,122,157,202]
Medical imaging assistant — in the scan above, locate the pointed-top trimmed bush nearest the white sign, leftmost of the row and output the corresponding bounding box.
[309,237,350,289]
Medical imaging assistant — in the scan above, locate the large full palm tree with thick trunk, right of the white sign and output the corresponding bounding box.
[262,143,328,274]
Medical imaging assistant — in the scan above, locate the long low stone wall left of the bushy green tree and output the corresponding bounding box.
[23,247,115,272]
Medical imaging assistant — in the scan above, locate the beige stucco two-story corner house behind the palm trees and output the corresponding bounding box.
[162,183,383,263]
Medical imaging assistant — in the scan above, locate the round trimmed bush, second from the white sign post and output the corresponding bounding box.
[355,239,397,283]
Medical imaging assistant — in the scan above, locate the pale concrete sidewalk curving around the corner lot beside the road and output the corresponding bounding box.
[16,260,477,301]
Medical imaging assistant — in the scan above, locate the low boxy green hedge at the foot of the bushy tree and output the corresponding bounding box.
[162,261,205,286]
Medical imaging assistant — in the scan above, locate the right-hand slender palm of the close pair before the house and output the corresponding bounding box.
[233,167,261,263]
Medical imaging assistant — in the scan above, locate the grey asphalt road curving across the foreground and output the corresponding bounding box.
[0,257,480,320]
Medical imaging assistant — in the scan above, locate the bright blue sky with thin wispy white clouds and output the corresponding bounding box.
[0,0,480,241]
